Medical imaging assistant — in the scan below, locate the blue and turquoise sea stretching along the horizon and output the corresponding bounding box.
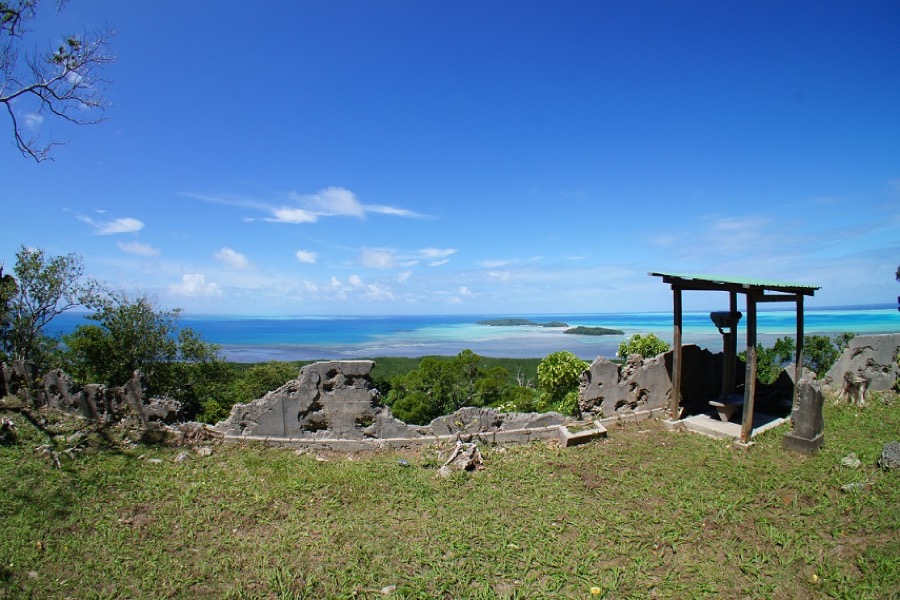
[51,307,900,362]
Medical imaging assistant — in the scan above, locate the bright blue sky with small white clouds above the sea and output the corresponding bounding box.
[0,0,900,315]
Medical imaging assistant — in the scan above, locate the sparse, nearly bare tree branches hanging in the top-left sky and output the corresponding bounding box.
[0,0,115,162]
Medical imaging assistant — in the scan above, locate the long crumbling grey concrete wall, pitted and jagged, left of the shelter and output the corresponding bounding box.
[216,360,569,450]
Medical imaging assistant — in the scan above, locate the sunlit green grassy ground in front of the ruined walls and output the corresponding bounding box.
[0,397,900,599]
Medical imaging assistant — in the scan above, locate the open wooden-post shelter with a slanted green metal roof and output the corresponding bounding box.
[649,273,819,444]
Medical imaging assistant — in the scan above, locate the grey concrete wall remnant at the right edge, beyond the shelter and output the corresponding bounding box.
[823,333,900,391]
